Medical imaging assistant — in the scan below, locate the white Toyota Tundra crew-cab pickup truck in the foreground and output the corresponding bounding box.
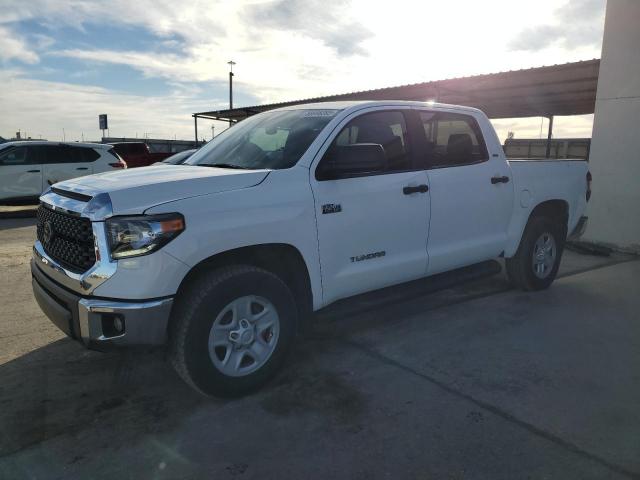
[32,101,591,395]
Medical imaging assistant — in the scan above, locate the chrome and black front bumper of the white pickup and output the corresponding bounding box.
[31,260,173,350]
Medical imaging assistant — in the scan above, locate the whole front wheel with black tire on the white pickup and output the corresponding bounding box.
[169,265,298,397]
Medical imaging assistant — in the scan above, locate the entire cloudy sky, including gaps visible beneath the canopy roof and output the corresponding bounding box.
[0,0,605,141]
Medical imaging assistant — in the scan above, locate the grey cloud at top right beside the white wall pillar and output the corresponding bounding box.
[509,0,606,51]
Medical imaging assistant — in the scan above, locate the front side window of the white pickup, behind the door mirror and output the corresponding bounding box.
[320,111,413,178]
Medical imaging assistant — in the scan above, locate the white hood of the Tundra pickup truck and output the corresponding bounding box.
[55,165,269,215]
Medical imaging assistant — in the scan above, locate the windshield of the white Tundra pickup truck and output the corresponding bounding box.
[185,109,338,170]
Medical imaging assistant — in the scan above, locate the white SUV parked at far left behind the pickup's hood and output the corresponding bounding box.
[0,141,127,204]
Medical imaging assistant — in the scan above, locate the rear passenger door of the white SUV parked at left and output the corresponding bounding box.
[43,145,96,188]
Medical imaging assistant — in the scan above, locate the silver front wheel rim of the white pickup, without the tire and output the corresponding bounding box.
[208,295,280,377]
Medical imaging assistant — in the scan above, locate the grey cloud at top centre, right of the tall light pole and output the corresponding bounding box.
[244,0,372,55]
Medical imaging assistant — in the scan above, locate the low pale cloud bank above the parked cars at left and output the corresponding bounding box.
[0,69,220,140]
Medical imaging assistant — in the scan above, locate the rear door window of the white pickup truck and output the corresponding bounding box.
[420,112,489,167]
